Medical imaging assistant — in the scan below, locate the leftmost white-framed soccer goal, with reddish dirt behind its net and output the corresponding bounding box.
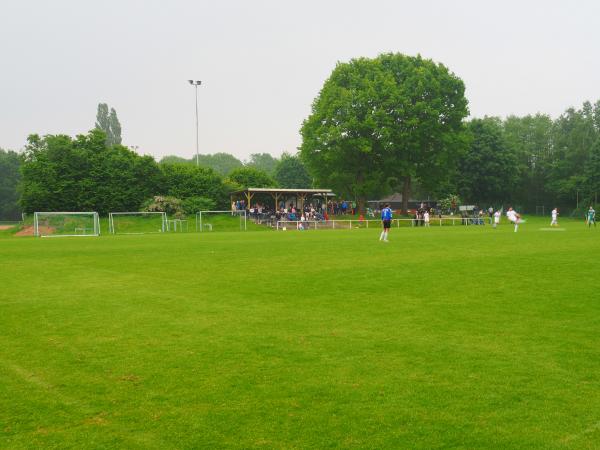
[33,212,100,237]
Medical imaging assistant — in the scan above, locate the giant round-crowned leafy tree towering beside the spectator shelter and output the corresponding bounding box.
[300,54,468,210]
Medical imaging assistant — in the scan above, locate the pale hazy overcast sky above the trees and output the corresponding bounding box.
[0,0,600,159]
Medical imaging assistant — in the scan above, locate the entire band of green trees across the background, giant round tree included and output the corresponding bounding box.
[0,54,600,217]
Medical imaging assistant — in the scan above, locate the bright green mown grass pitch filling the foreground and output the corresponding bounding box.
[0,219,600,449]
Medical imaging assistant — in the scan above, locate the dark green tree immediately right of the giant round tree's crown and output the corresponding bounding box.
[457,117,518,206]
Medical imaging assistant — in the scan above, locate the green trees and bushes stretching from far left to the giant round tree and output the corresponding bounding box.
[14,129,310,214]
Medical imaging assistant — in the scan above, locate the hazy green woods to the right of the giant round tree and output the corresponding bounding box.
[450,101,600,210]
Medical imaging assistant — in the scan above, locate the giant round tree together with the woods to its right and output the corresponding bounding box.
[301,54,600,211]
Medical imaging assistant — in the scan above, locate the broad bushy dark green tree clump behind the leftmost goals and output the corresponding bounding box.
[21,129,162,214]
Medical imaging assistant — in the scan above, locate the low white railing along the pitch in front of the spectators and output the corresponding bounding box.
[276,217,492,230]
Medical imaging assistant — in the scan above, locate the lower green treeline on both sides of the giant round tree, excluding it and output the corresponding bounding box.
[0,101,600,220]
